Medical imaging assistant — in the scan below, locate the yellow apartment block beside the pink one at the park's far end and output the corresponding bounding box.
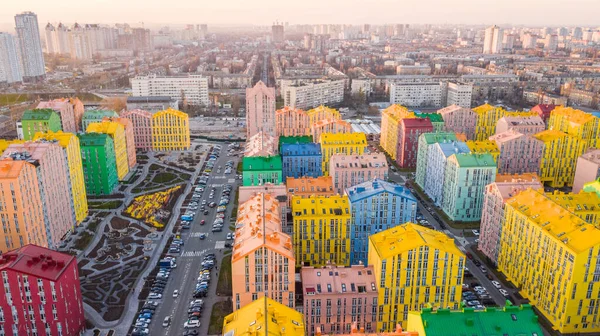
[152,108,191,151]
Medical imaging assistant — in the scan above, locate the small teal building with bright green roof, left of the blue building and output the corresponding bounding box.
[242,155,283,186]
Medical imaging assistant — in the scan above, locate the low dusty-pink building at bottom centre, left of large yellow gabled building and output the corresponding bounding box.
[300,265,378,336]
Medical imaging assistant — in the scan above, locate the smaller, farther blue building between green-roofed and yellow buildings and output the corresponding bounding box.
[280,142,323,182]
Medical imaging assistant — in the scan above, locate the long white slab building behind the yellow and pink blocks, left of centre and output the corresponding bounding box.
[131,75,210,106]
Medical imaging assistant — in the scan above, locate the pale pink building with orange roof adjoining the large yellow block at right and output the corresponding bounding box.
[478,174,543,264]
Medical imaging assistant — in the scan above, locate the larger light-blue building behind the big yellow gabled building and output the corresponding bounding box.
[346,179,417,265]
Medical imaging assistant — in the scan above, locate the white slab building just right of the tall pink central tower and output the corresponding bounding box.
[282,80,345,110]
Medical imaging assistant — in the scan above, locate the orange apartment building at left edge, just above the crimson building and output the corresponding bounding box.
[0,158,48,253]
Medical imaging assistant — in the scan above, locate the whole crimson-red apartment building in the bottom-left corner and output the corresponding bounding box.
[0,245,85,336]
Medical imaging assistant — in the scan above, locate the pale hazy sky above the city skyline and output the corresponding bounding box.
[0,0,600,27]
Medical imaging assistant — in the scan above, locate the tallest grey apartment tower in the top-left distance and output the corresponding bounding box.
[15,12,46,81]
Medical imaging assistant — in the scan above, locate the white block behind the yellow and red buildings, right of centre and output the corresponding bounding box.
[390,83,443,107]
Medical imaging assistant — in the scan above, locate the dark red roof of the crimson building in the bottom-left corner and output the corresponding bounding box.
[0,244,75,281]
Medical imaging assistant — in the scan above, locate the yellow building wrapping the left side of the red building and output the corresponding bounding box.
[379,104,416,161]
